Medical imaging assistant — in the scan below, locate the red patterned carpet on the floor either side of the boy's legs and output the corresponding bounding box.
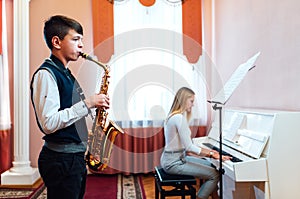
[0,174,146,199]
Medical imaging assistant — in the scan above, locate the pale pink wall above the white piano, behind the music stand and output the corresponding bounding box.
[210,0,300,111]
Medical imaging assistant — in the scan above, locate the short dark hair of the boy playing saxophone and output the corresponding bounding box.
[44,15,83,50]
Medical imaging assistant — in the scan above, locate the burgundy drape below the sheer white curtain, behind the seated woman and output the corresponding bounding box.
[90,126,206,174]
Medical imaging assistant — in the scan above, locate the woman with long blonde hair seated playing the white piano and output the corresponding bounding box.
[161,87,230,199]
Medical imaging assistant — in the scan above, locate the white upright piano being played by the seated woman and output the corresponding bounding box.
[193,108,300,199]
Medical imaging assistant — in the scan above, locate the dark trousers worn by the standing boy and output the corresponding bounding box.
[38,146,87,199]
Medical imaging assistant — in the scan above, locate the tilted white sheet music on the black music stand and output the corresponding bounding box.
[211,52,260,104]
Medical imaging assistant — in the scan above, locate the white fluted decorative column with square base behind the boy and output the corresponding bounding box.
[1,0,40,185]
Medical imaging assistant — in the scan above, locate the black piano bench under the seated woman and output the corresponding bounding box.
[154,166,197,199]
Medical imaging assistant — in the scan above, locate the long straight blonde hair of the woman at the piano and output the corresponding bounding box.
[167,87,195,121]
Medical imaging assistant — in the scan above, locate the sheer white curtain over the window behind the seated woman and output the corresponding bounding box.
[109,0,207,128]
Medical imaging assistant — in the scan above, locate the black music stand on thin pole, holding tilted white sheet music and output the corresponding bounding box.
[207,52,260,199]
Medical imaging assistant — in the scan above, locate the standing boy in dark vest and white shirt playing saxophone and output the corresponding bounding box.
[31,15,109,199]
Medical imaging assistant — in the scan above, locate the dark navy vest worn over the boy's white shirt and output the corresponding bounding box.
[30,56,88,144]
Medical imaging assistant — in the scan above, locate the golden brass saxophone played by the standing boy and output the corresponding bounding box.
[80,53,124,173]
